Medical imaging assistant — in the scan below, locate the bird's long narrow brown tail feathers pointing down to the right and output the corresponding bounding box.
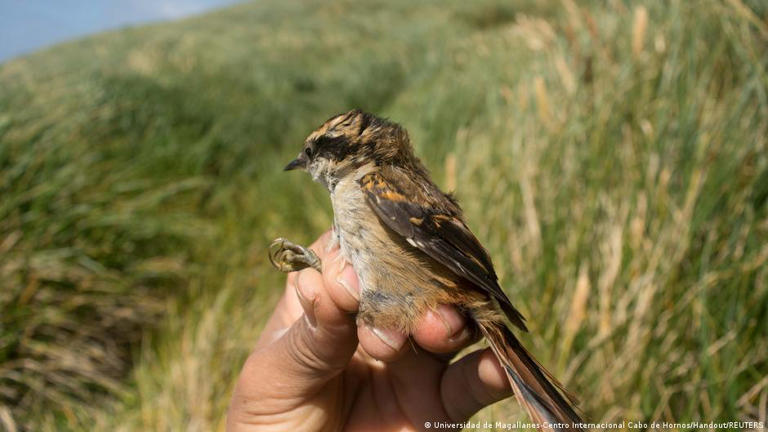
[478,321,582,431]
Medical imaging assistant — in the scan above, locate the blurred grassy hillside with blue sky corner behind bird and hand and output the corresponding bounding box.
[0,0,768,431]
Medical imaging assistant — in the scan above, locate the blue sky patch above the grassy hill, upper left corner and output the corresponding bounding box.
[0,0,241,62]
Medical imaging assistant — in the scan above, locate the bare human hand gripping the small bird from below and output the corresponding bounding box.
[227,233,511,432]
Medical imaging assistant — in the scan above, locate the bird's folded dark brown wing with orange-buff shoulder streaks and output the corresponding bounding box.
[359,167,526,330]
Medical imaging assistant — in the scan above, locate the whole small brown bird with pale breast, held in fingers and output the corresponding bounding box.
[270,110,581,430]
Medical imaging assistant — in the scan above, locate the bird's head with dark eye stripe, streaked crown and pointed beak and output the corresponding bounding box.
[285,110,418,190]
